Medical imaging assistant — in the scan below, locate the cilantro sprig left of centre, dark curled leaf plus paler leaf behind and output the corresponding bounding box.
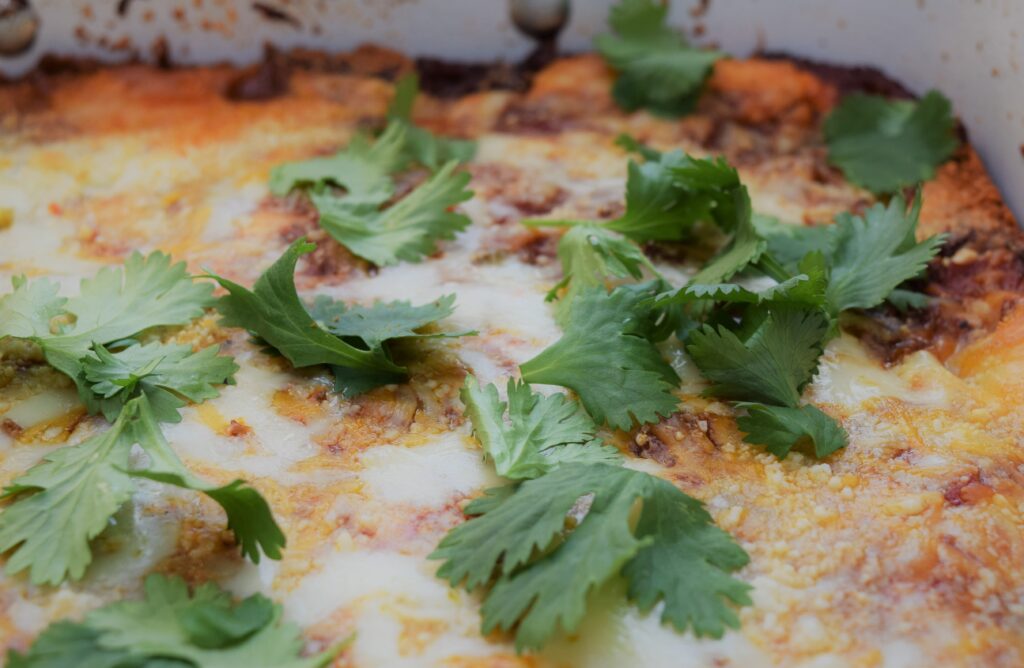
[212,238,471,396]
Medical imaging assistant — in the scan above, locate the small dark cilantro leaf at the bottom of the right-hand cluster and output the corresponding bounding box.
[736,403,848,459]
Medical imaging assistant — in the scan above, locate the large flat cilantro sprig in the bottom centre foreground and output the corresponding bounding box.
[429,376,751,652]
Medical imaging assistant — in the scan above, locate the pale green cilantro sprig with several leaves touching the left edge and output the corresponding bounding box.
[0,253,285,584]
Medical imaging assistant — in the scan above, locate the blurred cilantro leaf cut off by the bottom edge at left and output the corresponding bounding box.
[8,575,343,668]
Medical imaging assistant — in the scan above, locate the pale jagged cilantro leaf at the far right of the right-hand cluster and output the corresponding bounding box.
[826,193,945,312]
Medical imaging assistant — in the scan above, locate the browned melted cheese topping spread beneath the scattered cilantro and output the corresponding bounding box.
[0,57,1024,668]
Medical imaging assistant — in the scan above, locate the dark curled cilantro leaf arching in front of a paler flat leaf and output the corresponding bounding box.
[213,238,406,383]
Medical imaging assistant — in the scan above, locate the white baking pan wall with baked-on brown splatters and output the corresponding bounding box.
[0,0,1024,220]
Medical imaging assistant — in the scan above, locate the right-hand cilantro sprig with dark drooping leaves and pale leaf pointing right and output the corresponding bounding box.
[659,194,944,457]
